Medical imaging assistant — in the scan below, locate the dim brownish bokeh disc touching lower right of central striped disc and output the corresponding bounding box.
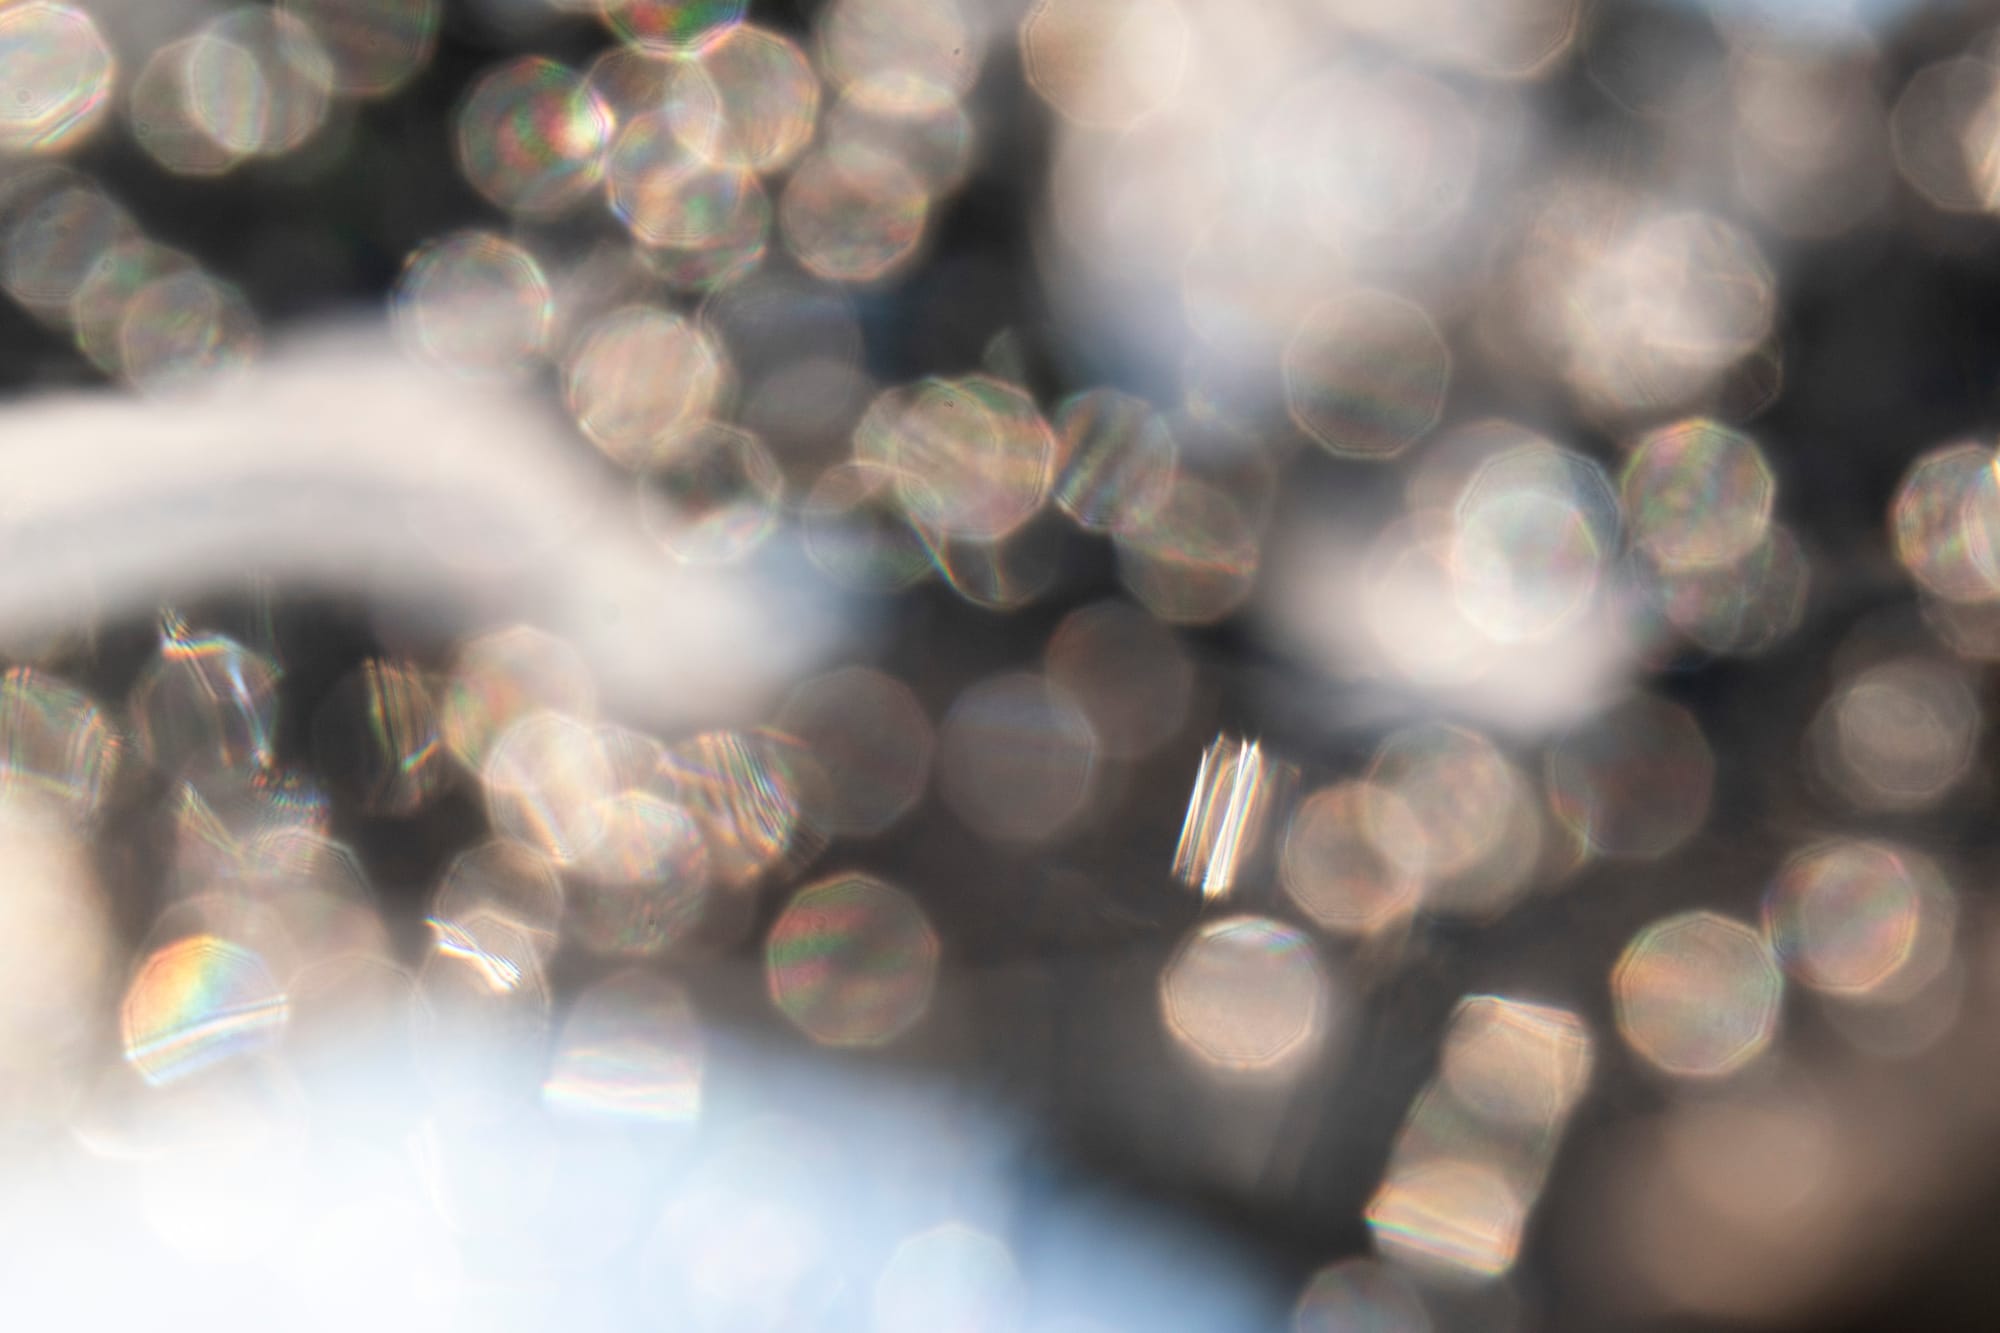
[1116,472,1264,624]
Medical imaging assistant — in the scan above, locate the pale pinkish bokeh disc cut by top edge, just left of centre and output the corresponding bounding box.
[820,0,986,112]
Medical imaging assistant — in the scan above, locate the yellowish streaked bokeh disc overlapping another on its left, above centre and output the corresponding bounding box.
[854,374,1056,542]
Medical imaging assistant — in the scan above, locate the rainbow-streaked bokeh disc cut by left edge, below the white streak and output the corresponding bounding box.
[0,667,122,825]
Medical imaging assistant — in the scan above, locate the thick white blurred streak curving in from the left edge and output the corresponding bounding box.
[0,326,838,725]
